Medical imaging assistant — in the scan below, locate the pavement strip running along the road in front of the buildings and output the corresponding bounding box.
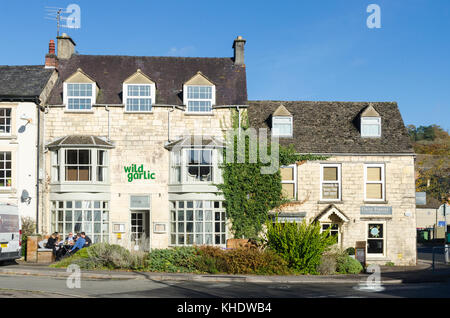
[0,260,450,285]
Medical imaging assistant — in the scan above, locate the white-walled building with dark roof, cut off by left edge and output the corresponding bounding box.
[0,65,57,224]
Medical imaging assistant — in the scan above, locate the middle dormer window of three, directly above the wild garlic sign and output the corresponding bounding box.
[123,69,156,112]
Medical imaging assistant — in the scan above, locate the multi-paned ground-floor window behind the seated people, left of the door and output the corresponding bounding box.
[51,200,109,243]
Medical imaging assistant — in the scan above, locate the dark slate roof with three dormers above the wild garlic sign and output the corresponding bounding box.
[48,55,247,105]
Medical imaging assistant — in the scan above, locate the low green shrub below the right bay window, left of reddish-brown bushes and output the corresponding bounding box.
[146,247,200,273]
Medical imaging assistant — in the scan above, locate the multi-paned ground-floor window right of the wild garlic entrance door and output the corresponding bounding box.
[170,200,226,245]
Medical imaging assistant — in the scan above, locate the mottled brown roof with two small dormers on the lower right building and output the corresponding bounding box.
[248,101,414,154]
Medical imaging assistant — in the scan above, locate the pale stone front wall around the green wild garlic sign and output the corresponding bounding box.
[42,106,231,248]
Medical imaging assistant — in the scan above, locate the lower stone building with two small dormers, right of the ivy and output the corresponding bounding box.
[248,101,416,265]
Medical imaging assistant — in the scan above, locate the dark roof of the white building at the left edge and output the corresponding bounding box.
[0,65,54,99]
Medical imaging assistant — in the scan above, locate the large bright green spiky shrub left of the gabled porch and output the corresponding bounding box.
[266,220,336,274]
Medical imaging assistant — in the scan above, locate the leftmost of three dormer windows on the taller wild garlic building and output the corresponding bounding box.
[64,69,97,111]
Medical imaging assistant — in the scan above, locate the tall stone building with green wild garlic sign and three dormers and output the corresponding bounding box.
[40,34,247,250]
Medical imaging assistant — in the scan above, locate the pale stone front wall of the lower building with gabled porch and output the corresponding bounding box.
[276,155,416,265]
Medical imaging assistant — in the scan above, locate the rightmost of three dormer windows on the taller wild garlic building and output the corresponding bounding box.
[183,72,216,113]
